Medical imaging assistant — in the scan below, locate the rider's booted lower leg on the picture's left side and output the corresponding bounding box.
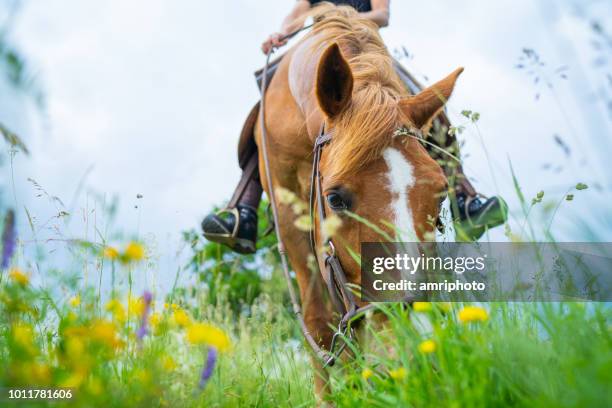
[202,154,262,254]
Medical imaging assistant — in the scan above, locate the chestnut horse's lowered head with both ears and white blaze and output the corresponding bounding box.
[315,43,463,294]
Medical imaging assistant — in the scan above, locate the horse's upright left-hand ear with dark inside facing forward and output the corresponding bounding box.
[316,43,353,118]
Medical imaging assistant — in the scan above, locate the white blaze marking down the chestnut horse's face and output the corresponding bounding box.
[383,147,416,240]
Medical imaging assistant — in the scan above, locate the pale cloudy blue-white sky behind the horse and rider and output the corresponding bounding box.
[0,0,612,290]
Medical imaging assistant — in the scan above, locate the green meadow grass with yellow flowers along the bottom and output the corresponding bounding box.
[0,236,612,407]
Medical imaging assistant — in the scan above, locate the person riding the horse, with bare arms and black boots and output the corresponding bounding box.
[202,0,506,253]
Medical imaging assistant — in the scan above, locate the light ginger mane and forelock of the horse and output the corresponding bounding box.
[308,3,408,179]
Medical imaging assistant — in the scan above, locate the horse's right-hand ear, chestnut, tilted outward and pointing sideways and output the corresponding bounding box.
[400,68,463,129]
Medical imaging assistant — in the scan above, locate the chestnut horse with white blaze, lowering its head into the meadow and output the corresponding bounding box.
[255,6,462,397]
